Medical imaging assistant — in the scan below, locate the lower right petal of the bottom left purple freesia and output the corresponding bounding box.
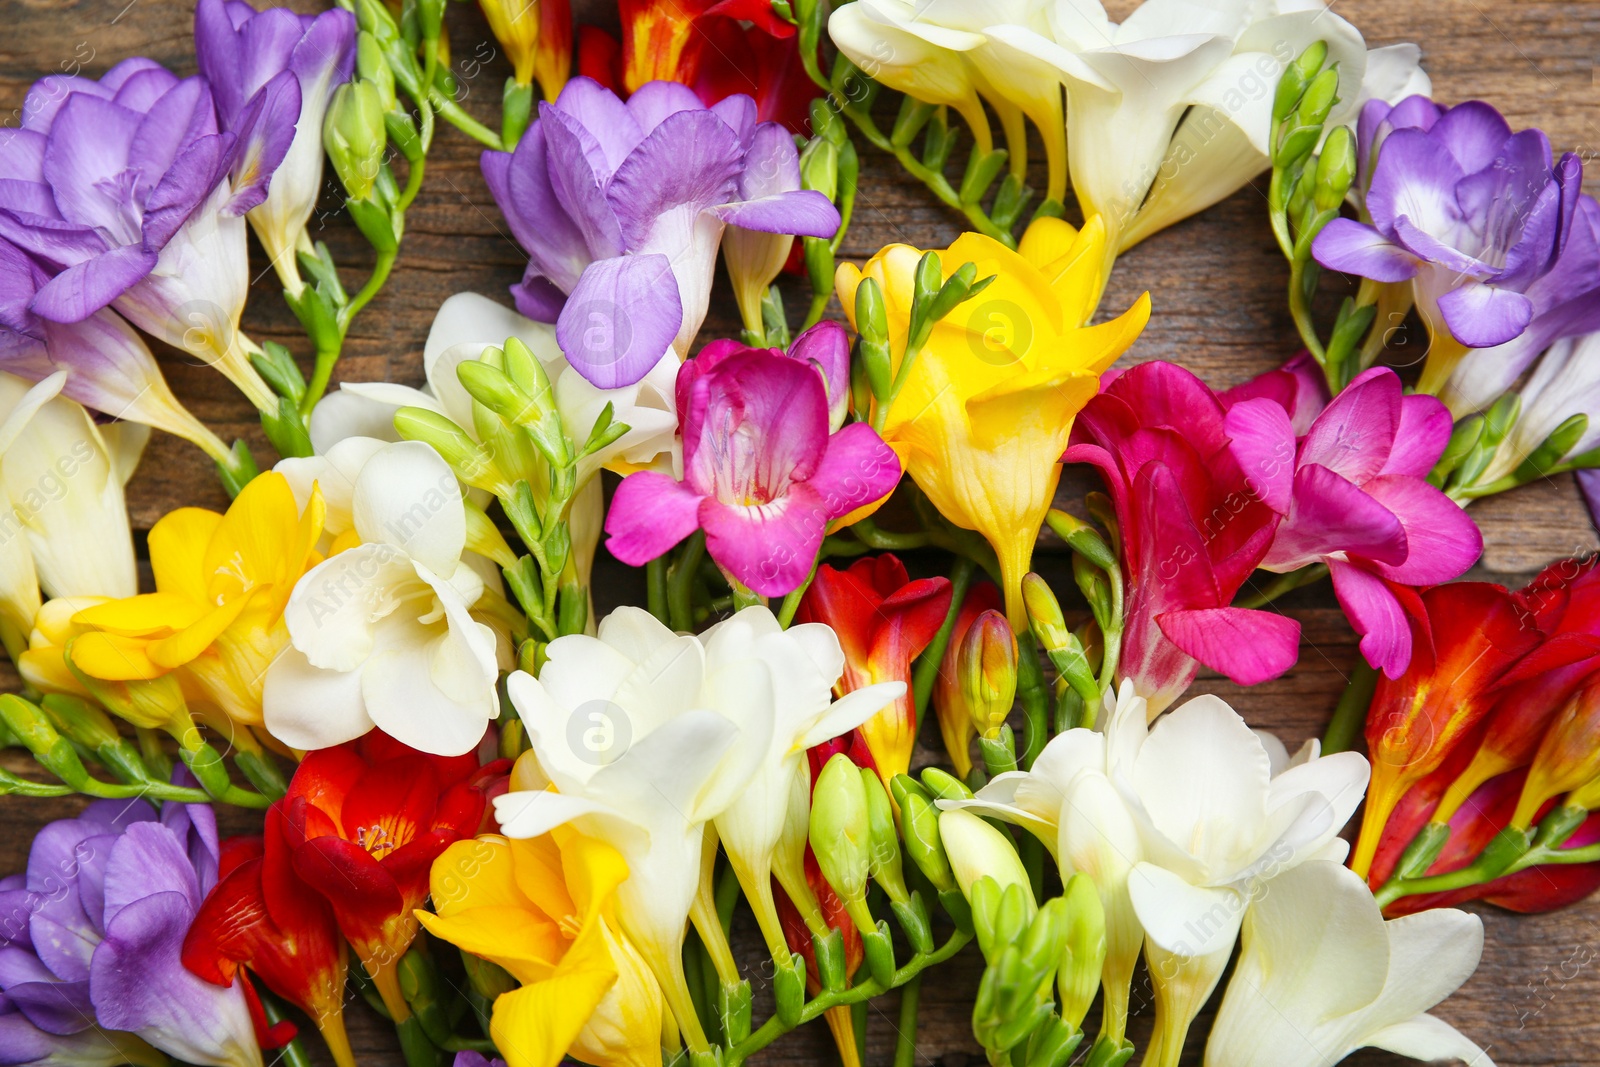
[90,893,254,1064]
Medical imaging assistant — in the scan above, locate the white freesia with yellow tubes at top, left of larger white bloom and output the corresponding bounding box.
[827,0,1067,200]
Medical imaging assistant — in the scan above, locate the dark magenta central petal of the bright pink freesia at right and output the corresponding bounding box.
[1261,466,1406,571]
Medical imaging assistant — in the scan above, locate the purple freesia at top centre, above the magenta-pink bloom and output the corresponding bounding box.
[482,77,838,389]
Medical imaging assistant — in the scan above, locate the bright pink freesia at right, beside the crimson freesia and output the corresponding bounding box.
[1226,366,1483,678]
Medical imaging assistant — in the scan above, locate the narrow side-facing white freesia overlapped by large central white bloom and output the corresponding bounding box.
[701,608,906,958]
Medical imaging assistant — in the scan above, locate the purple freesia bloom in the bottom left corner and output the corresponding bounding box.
[0,800,261,1067]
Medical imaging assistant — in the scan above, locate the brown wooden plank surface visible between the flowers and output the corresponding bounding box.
[0,0,1600,1067]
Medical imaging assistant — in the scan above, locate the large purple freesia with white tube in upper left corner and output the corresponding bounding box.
[0,59,277,411]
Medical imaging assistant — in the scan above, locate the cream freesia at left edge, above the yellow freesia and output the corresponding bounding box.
[0,371,150,607]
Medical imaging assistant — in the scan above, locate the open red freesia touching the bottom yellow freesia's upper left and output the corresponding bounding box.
[278,731,507,1022]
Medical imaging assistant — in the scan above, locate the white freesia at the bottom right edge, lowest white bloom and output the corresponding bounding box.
[1205,862,1494,1067]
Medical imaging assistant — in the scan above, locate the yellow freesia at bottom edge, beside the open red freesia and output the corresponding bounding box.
[416,827,662,1067]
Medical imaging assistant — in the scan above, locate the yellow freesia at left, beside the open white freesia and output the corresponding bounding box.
[67,472,325,726]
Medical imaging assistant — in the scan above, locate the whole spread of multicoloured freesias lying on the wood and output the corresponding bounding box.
[0,0,1600,1067]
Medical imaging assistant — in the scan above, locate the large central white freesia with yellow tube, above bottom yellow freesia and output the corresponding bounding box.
[494,608,812,1051]
